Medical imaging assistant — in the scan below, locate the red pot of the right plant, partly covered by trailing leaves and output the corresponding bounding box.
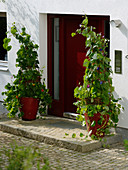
[84,113,109,138]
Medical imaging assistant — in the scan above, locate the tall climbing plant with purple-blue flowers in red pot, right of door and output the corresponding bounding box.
[72,16,122,138]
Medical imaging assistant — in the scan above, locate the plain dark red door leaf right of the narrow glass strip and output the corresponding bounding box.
[64,17,86,112]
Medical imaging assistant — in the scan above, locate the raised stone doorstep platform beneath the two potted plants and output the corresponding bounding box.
[0,116,121,152]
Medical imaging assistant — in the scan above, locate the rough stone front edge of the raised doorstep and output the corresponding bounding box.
[0,123,122,152]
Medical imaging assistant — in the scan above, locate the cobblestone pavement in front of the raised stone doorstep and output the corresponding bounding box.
[0,131,128,170]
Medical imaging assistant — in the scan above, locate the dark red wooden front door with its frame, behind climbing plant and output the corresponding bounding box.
[48,15,109,116]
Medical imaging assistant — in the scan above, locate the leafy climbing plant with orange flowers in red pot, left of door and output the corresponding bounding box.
[2,23,51,120]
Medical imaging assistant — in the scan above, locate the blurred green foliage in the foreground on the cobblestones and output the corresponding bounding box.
[0,144,50,170]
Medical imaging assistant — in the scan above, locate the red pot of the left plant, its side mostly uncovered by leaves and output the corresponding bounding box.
[20,97,39,120]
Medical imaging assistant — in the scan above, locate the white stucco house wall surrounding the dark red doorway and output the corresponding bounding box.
[0,0,128,128]
